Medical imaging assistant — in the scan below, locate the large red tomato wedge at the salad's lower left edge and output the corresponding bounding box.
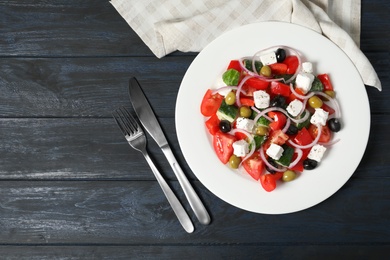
[213,131,237,164]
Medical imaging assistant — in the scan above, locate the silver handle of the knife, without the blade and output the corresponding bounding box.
[161,144,211,225]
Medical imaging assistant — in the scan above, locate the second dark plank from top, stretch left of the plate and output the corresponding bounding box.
[0,57,193,117]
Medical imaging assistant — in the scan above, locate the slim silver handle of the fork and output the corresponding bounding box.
[142,152,194,233]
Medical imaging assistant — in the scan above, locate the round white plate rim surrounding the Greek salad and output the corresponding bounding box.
[175,22,370,214]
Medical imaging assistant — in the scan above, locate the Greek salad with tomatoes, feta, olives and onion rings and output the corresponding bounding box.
[200,46,341,192]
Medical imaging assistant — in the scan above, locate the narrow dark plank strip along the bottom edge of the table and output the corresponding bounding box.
[0,243,390,260]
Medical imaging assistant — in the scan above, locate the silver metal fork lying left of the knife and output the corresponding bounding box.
[113,107,194,233]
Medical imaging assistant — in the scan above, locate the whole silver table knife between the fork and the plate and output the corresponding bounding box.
[129,77,211,225]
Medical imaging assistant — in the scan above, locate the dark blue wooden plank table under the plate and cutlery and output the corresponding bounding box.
[0,0,390,259]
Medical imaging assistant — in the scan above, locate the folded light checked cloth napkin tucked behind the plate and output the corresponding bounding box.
[110,0,382,90]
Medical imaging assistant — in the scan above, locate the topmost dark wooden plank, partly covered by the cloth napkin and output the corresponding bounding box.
[0,0,390,56]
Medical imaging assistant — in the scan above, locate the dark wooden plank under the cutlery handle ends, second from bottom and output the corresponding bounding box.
[0,178,390,246]
